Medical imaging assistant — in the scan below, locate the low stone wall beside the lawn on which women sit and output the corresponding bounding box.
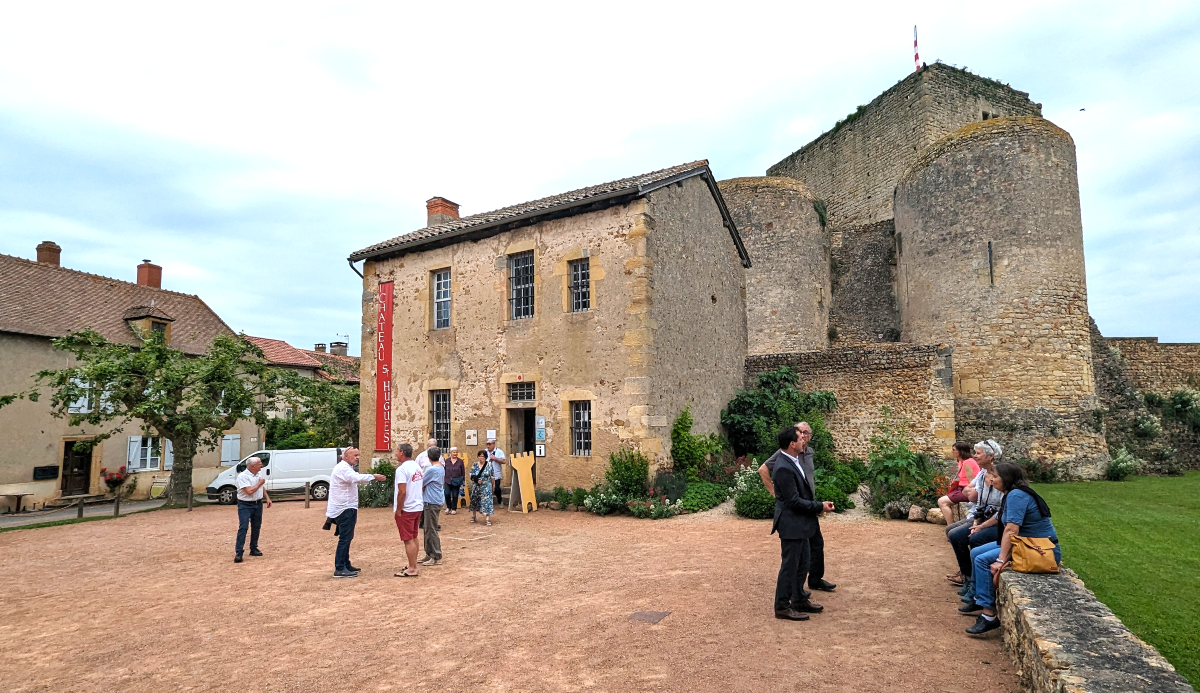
[997,570,1194,693]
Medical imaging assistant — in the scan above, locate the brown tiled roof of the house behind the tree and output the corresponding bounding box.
[0,254,234,354]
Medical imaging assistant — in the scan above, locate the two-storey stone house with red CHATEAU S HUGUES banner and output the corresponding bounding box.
[350,161,750,487]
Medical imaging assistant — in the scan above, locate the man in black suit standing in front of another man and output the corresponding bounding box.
[770,426,833,621]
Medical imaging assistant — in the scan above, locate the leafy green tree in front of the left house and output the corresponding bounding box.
[0,329,304,505]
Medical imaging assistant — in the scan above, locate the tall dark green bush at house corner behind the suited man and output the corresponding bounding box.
[721,366,838,455]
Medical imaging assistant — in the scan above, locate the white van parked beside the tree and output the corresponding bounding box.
[204,447,342,505]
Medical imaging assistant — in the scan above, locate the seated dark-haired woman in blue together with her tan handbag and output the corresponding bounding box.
[959,462,1062,635]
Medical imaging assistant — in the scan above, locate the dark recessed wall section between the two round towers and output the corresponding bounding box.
[829,219,900,347]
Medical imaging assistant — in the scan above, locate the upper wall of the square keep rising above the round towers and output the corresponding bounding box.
[767,64,1042,229]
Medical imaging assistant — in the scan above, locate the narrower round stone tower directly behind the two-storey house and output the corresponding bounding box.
[718,176,830,355]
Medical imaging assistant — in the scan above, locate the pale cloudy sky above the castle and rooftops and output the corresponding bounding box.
[0,0,1200,354]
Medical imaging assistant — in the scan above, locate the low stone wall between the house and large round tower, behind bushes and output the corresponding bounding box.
[746,344,955,459]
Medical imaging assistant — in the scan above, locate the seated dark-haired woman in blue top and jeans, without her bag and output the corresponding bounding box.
[959,462,1062,635]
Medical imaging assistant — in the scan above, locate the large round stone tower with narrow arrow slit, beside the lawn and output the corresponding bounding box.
[894,117,1108,477]
